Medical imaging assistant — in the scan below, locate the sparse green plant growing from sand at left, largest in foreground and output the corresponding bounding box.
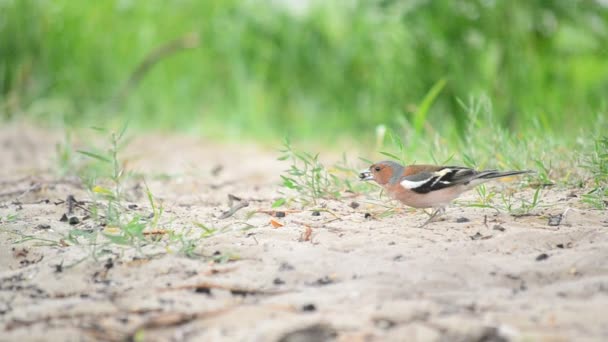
[66,125,215,258]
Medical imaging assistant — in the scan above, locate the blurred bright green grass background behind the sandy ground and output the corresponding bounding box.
[0,0,608,141]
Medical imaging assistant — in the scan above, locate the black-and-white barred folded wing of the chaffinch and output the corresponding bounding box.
[400,165,479,194]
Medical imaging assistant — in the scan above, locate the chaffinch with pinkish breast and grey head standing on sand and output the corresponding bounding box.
[359,160,534,227]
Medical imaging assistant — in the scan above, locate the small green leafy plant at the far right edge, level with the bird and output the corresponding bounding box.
[581,137,608,210]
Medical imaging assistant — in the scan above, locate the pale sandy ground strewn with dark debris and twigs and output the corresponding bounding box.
[0,125,608,342]
